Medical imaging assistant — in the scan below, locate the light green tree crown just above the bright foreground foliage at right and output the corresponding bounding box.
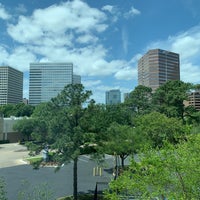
[134,112,190,147]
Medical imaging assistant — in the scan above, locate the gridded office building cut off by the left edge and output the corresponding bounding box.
[0,66,23,105]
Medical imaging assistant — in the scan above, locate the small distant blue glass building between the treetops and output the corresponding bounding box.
[106,90,121,105]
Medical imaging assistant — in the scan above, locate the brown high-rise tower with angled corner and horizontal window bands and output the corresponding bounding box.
[138,49,180,91]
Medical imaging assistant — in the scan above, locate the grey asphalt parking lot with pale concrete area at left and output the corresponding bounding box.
[0,144,113,200]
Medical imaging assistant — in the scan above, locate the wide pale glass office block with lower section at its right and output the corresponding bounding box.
[29,63,81,105]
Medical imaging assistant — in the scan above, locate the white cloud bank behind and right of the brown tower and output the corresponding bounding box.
[146,26,200,83]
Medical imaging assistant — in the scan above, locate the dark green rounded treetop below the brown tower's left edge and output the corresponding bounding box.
[125,85,152,114]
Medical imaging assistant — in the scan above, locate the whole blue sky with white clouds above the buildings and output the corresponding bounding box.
[0,0,200,103]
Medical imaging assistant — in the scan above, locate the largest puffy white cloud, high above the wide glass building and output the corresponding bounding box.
[8,0,107,44]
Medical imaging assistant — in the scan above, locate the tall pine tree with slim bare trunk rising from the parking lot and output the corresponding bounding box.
[28,84,91,200]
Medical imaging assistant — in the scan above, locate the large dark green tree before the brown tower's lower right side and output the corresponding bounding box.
[153,80,193,122]
